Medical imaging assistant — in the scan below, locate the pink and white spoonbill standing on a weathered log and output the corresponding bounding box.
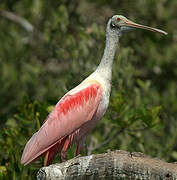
[21,15,167,166]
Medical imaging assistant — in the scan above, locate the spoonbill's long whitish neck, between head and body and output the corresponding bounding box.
[96,33,119,81]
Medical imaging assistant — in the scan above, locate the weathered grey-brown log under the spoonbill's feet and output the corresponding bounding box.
[37,151,177,180]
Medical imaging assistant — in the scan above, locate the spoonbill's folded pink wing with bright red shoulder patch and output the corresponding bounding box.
[21,82,102,165]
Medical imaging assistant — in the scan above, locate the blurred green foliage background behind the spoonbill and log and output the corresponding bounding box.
[0,0,177,180]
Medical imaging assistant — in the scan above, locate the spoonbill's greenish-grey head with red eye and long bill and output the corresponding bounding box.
[107,15,167,36]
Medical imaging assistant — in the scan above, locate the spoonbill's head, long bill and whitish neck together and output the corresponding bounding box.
[96,15,167,81]
